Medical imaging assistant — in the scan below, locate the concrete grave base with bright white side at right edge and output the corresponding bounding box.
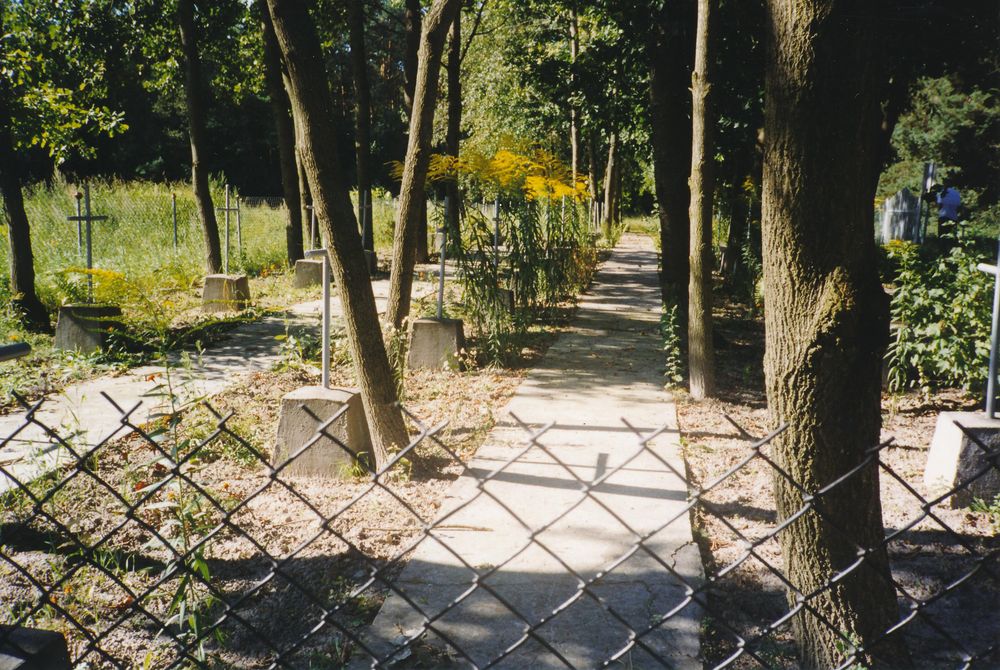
[924,412,1000,508]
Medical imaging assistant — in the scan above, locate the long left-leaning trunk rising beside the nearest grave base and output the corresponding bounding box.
[268,0,408,467]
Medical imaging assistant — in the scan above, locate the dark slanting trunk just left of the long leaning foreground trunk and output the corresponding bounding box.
[257,0,303,267]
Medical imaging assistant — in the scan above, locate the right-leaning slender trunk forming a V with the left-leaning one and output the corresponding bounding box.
[386,0,462,328]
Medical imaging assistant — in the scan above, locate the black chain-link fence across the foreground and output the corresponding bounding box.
[0,398,1000,668]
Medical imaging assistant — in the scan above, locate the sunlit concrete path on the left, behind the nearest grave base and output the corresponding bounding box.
[0,279,433,493]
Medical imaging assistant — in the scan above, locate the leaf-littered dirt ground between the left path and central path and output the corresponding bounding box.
[0,342,558,668]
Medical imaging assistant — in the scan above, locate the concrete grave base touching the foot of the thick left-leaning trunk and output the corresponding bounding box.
[271,386,372,478]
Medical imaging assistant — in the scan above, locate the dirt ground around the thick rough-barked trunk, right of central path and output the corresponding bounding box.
[677,306,1000,670]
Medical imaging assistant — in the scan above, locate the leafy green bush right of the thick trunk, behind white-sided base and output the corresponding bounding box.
[887,242,993,393]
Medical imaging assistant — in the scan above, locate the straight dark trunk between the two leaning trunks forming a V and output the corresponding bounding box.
[347,0,375,258]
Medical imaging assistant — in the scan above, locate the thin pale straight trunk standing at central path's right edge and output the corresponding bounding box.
[688,0,717,400]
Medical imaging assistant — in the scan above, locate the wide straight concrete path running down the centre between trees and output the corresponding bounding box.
[360,236,703,669]
